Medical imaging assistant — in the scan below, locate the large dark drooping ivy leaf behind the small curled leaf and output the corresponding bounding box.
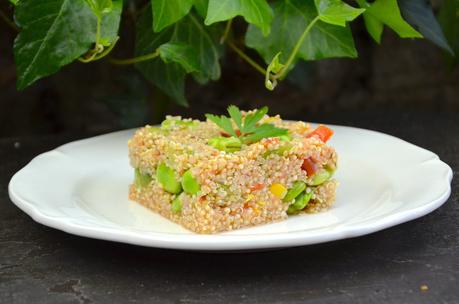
[135,5,221,105]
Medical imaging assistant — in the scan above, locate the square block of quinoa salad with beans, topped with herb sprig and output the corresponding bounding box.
[128,106,337,234]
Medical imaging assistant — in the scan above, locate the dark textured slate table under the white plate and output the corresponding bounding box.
[0,113,459,304]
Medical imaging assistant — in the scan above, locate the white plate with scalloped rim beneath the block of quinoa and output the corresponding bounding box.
[9,126,452,251]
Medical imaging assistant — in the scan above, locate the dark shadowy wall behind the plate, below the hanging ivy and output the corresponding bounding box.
[0,1,459,137]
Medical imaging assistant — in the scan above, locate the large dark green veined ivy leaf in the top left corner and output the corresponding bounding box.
[14,0,96,89]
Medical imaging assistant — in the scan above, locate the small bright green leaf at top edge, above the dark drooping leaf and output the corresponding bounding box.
[151,0,193,32]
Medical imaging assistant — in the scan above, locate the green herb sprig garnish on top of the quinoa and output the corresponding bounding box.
[206,105,288,144]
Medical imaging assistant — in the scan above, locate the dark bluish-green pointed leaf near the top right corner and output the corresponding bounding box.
[399,0,453,54]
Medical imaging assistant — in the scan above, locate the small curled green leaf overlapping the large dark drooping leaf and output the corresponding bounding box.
[158,43,199,73]
